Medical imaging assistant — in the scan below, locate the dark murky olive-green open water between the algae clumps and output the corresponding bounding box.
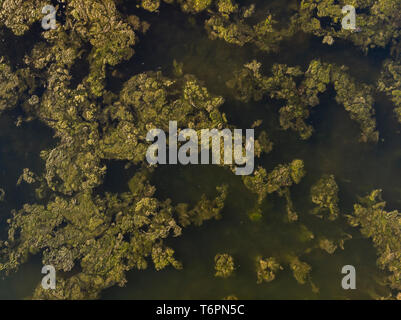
[0,1,401,299]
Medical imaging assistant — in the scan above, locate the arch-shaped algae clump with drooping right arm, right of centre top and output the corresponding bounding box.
[227,60,379,142]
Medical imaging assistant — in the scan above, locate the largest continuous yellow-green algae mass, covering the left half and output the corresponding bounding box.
[0,0,231,299]
